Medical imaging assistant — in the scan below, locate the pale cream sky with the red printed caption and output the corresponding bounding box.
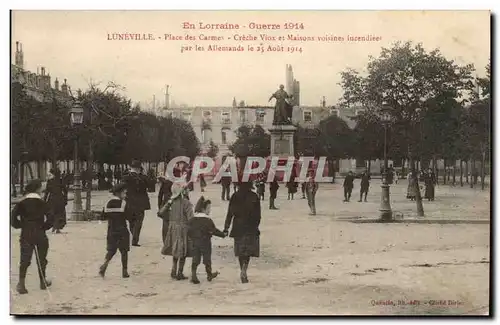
[11,11,490,106]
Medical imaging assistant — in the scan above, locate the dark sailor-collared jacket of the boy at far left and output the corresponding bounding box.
[11,193,53,240]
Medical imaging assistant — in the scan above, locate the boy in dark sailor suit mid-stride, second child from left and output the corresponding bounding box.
[99,184,130,278]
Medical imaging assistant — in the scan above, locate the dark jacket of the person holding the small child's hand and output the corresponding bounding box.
[224,189,261,237]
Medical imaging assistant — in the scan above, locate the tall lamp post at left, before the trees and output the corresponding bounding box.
[70,100,83,221]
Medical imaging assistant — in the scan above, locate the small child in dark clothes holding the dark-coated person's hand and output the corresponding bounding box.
[188,196,226,284]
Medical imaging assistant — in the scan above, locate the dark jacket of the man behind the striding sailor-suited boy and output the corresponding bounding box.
[123,172,151,212]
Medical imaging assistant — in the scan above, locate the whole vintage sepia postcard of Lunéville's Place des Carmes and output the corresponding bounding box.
[10,10,492,316]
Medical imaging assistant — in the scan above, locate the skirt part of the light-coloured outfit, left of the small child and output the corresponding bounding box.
[161,222,193,258]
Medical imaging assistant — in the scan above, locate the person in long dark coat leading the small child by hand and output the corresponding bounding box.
[224,182,261,283]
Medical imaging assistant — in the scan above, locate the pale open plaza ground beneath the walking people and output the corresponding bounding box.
[10,180,490,315]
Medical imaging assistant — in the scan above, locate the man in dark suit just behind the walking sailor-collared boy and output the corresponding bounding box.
[123,160,151,246]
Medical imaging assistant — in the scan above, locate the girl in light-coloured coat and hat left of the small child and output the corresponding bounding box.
[161,183,194,280]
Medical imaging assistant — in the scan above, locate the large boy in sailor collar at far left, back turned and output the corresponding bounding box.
[11,180,53,294]
